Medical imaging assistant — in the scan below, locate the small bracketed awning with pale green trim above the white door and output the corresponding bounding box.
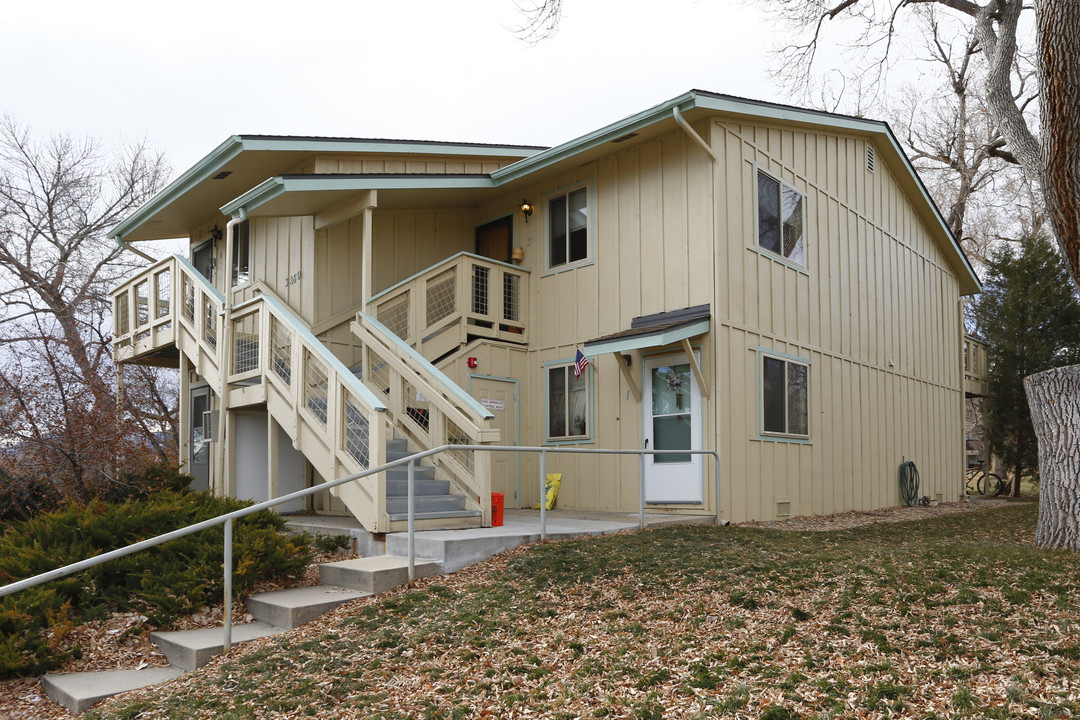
[584,304,712,402]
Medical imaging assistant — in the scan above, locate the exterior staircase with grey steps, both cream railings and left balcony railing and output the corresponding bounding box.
[112,256,496,533]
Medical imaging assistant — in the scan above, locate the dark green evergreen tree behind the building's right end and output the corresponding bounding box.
[975,236,1080,494]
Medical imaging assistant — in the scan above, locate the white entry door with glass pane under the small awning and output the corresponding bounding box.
[642,354,704,503]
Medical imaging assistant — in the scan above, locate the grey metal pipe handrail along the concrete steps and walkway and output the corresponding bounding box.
[0,445,721,651]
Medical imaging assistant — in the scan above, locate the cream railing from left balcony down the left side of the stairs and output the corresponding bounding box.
[112,256,390,532]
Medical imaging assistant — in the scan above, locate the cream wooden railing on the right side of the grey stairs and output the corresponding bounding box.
[352,313,500,526]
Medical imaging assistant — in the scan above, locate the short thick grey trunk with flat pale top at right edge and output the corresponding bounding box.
[1024,365,1080,551]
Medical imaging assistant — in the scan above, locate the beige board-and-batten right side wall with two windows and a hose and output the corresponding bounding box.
[712,121,963,521]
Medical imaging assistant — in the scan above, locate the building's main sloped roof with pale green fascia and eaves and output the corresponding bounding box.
[110,90,982,294]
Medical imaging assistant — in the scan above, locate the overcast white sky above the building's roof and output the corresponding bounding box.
[0,0,781,174]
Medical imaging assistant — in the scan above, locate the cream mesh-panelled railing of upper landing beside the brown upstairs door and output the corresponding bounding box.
[368,253,529,357]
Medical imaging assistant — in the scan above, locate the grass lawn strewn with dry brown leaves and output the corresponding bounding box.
[89,504,1080,720]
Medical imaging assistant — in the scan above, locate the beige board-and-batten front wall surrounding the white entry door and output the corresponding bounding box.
[462,126,716,513]
